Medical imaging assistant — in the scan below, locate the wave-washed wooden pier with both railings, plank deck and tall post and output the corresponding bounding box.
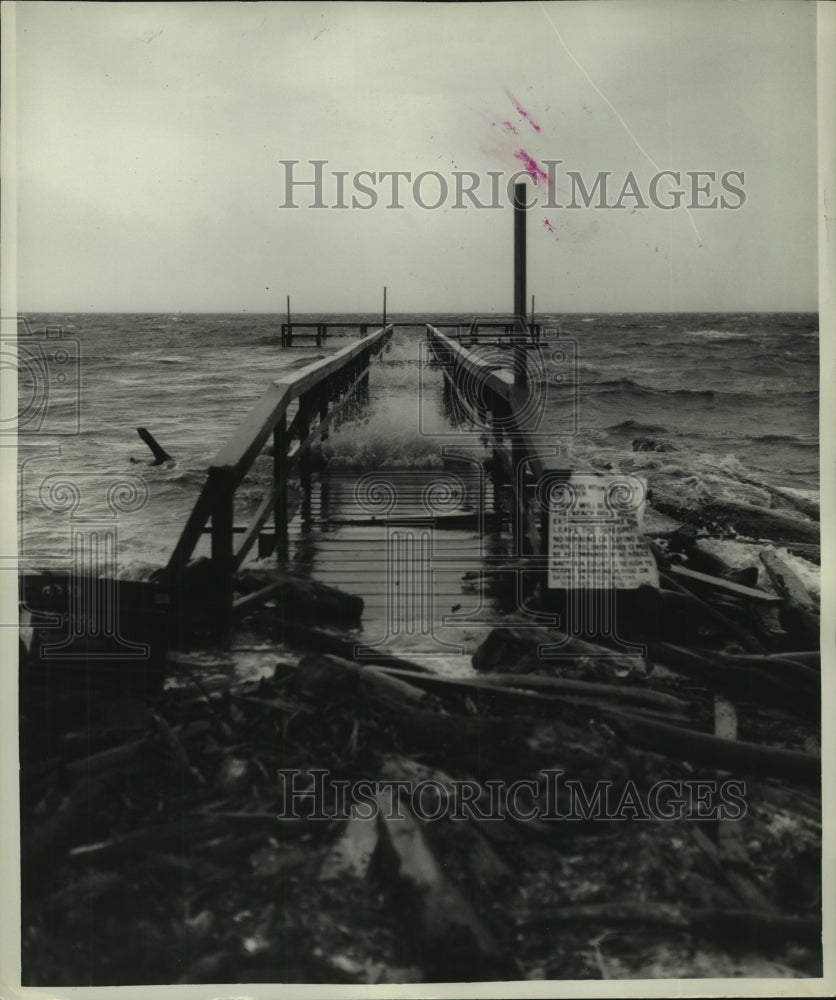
[165,185,568,641]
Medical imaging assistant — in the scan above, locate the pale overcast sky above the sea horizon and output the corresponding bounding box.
[17,0,817,312]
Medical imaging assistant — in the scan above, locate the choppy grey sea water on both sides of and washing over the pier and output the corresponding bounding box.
[19,314,819,576]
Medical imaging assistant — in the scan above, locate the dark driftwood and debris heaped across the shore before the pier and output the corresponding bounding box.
[21,505,822,986]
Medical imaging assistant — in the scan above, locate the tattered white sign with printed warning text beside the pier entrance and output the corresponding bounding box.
[548,473,659,590]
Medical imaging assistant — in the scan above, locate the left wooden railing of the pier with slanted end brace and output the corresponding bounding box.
[166,324,392,632]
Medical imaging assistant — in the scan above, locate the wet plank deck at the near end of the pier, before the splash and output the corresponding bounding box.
[288,466,510,663]
